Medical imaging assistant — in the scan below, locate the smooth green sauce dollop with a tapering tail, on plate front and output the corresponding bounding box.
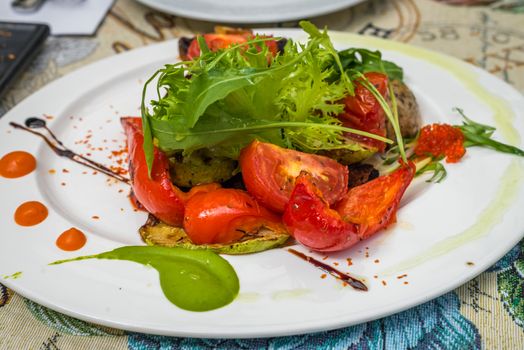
[50,246,240,311]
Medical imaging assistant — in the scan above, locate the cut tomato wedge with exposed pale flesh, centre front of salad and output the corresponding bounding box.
[239,140,348,213]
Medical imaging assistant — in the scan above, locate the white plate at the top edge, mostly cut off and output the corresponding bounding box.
[137,0,363,23]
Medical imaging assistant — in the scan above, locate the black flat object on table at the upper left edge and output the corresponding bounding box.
[0,22,49,97]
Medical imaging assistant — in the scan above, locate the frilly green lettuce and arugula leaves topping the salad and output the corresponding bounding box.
[142,21,402,174]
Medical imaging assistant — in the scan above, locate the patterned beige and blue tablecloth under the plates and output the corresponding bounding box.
[0,0,524,350]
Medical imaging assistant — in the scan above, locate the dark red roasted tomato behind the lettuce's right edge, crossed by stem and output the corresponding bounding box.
[338,72,388,152]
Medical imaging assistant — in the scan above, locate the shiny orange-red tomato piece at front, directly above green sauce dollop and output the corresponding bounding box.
[184,188,284,244]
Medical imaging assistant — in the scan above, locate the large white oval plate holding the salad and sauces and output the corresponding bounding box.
[0,30,524,337]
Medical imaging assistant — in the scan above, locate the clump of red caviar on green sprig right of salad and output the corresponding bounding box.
[415,124,466,163]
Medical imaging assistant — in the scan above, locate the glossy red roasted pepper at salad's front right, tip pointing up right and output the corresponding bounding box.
[283,165,415,252]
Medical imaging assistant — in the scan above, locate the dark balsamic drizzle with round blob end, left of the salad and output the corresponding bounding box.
[9,117,130,185]
